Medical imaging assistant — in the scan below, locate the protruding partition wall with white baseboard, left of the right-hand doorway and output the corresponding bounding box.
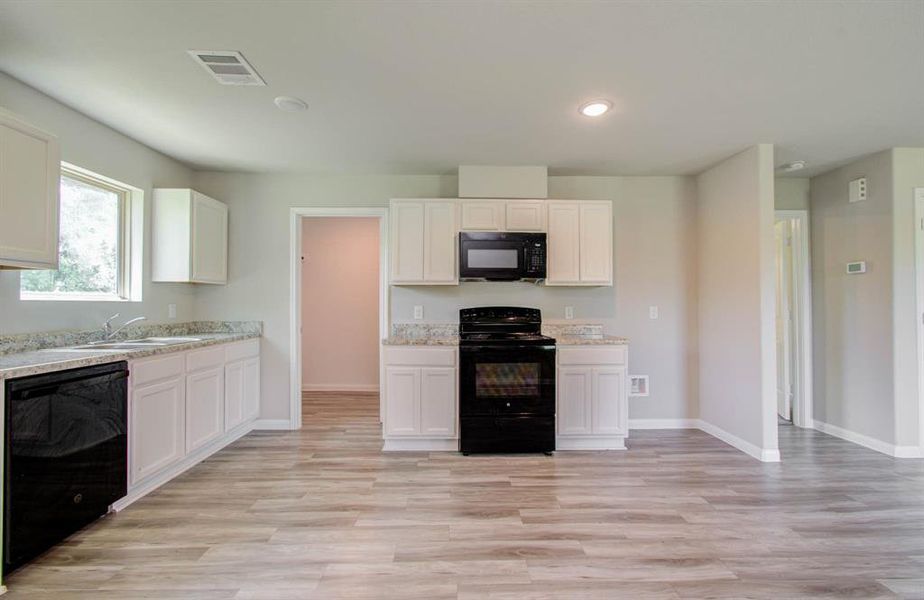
[697,144,779,460]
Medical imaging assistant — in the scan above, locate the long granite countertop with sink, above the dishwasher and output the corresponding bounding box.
[0,326,262,380]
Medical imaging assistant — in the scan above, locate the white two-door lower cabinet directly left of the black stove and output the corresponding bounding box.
[383,346,459,450]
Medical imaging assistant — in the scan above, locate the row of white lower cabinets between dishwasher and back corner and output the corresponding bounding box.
[122,339,260,509]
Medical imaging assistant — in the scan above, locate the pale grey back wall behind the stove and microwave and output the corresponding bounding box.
[195,172,697,419]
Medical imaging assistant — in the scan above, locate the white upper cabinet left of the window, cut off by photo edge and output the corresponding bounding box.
[0,110,61,269]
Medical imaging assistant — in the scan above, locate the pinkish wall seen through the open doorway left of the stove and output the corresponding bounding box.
[302,217,379,390]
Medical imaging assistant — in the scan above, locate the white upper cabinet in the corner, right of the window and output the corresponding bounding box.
[151,188,228,284]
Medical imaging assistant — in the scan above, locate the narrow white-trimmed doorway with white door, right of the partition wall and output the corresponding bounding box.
[774,210,814,428]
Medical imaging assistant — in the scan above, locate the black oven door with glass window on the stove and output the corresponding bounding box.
[459,346,555,417]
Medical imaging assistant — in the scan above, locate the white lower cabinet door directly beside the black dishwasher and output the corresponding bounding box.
[129,377,186,485]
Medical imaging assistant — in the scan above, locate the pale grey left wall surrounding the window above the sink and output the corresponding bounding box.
[0,73,195,334]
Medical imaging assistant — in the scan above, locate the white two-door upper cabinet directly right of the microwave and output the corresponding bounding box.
[546,200,613,285]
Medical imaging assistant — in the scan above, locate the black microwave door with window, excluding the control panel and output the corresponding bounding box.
[459,233,526,281]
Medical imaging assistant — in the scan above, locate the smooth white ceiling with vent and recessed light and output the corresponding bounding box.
[0,0,924,175]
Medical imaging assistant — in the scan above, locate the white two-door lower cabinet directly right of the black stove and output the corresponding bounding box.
[556,346,629,450]
